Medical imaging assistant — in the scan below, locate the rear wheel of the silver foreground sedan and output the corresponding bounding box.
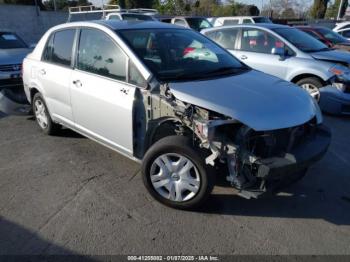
[32,93,60,135]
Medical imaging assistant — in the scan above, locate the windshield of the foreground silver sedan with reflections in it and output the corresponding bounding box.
[119,29,248,81]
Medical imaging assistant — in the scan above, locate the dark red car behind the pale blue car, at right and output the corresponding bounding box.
[296,26,350,51]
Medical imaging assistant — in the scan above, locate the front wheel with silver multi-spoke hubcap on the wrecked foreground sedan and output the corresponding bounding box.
[142,136,214,209]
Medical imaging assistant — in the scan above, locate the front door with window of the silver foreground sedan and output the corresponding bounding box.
[70,29,136,155]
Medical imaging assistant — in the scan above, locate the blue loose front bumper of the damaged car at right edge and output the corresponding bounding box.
[319,86,350,115]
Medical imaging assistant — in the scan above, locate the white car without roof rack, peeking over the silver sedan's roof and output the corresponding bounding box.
[161,16,213,31]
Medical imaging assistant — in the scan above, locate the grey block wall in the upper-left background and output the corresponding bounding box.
[0,4,68,44]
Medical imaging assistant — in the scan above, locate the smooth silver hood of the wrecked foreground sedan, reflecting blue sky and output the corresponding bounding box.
[169,70,317,131]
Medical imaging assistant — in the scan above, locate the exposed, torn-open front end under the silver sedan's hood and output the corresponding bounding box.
[134,84,329,198]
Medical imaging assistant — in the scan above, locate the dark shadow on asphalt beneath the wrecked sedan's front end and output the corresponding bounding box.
[196,182,350,225]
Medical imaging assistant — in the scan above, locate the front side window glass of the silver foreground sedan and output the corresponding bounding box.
[77,29,127,81]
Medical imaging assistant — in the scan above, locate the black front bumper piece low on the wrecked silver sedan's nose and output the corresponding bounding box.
[255,125,331,183]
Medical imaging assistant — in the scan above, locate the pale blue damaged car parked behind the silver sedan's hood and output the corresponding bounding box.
[203,24,350,114]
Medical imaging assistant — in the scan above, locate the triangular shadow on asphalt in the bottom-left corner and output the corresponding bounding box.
[0,217,94,261]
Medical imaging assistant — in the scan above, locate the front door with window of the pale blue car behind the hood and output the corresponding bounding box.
[232,28,292,78]
